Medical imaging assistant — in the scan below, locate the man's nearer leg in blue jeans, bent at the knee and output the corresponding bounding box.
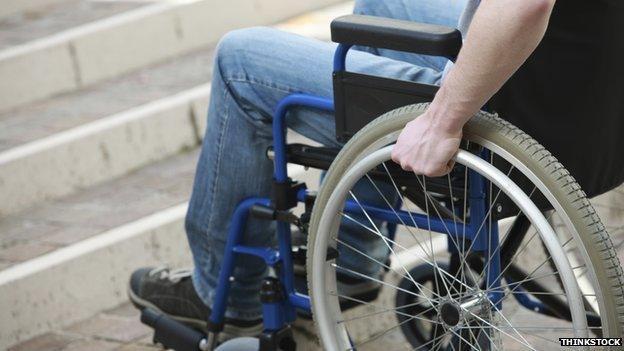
[187,28,439,319]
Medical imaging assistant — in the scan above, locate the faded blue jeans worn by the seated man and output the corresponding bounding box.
[186,0,464,320]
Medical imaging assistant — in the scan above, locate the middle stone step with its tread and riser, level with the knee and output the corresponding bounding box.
[0,3,352,218]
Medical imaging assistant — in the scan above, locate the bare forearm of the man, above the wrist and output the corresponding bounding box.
[429,0,554,130]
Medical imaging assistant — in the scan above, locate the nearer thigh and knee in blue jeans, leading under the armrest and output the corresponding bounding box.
[217,28,441,145]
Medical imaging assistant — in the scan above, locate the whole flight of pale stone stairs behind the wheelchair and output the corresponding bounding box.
[0,0,352,350]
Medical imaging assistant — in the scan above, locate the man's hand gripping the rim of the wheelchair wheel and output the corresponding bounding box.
[392,111,462,177]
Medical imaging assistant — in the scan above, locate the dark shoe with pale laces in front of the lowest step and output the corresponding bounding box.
[128,267,263,336]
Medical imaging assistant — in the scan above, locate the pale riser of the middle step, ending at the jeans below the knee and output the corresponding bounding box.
[0,85,210,217]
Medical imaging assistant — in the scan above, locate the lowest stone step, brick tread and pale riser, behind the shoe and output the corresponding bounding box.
[0,140,319,349]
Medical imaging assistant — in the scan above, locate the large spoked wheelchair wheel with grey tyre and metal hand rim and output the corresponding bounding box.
[307,104,624,350]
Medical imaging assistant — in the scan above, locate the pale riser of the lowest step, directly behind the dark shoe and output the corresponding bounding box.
[0,204,191,350]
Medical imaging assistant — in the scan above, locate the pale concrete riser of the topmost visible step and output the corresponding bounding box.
[0,0,338,111]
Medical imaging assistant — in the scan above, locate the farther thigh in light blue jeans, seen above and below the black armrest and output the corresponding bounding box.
[353,0,467,71]
